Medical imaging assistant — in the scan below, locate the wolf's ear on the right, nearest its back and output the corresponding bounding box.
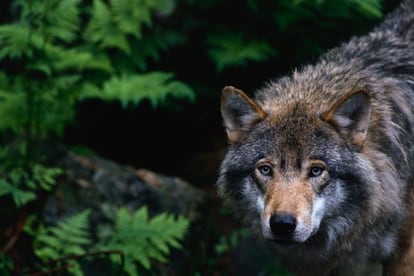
[322,91,371,149]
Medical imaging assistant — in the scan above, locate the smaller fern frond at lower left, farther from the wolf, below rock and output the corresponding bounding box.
[29,210,91,275]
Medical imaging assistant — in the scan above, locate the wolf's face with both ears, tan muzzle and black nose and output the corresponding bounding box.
[218,87,370,244]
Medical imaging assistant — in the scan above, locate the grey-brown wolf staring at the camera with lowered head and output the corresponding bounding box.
[216,0,414,275]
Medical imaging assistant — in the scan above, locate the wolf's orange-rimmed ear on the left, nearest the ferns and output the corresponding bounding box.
[221,86,267,143]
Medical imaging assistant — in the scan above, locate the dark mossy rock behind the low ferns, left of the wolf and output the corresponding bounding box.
[43,153,205,229]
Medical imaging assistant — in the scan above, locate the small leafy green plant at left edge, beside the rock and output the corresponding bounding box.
[0,164,62,207]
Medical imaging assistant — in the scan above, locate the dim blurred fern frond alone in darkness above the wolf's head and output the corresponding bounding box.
[207,33,276,72]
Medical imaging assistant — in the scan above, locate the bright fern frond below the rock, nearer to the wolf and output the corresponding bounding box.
[96,206,189,275]
